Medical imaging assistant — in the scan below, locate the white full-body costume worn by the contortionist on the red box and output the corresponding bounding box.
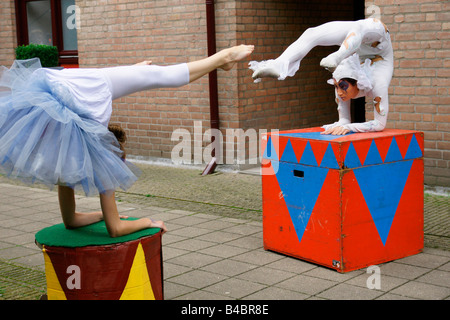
[250,18,394,132]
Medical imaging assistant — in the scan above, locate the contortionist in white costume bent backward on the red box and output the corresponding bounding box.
[250,18,394,135]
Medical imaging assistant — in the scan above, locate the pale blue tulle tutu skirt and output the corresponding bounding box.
[0,59,139,196]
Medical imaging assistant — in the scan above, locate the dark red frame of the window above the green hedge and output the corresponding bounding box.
[14,0,78,65]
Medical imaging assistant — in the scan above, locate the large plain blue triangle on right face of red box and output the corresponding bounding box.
[353,161,412,245]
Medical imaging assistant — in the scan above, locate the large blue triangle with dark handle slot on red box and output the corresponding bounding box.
[276,164,328,242]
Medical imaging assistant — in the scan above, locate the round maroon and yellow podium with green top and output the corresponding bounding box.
[36,218,164,300]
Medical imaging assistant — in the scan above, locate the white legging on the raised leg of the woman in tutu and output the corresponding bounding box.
[102,63,189,100]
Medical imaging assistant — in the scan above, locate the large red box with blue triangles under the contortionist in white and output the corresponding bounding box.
[262,128,423,272]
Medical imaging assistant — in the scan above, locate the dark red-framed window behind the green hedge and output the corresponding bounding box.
[15,0,78,66]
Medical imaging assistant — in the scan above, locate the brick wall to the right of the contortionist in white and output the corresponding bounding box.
[366,0,450,186]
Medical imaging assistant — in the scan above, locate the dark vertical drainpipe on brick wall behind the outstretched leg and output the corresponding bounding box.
[202,0,220,176]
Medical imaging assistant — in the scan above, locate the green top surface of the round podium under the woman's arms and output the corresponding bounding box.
[35,218,161,248]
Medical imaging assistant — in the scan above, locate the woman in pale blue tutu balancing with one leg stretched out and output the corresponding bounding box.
[0,45,254,237]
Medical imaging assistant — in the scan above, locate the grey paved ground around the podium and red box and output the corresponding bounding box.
[0,163,450,301]
